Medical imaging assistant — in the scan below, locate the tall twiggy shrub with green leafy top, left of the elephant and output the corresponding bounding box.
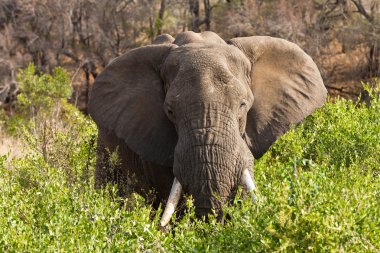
[5,64,97,180]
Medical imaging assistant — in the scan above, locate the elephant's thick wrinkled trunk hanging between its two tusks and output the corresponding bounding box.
[174,103,249,215]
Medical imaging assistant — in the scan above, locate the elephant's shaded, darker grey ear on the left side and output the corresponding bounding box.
[88,44,177,166]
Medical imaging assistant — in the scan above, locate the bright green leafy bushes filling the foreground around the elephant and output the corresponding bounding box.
[0,66,380,252]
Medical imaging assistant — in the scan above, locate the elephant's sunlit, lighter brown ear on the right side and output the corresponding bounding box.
[229,36,327,158]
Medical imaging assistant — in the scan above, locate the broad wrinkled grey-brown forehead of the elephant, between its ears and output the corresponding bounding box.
[164,43,251,99]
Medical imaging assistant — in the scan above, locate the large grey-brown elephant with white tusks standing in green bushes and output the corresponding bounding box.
[88,31,327,226]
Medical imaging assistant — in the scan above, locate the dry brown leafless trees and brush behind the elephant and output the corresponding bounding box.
[0,0,380,114]
